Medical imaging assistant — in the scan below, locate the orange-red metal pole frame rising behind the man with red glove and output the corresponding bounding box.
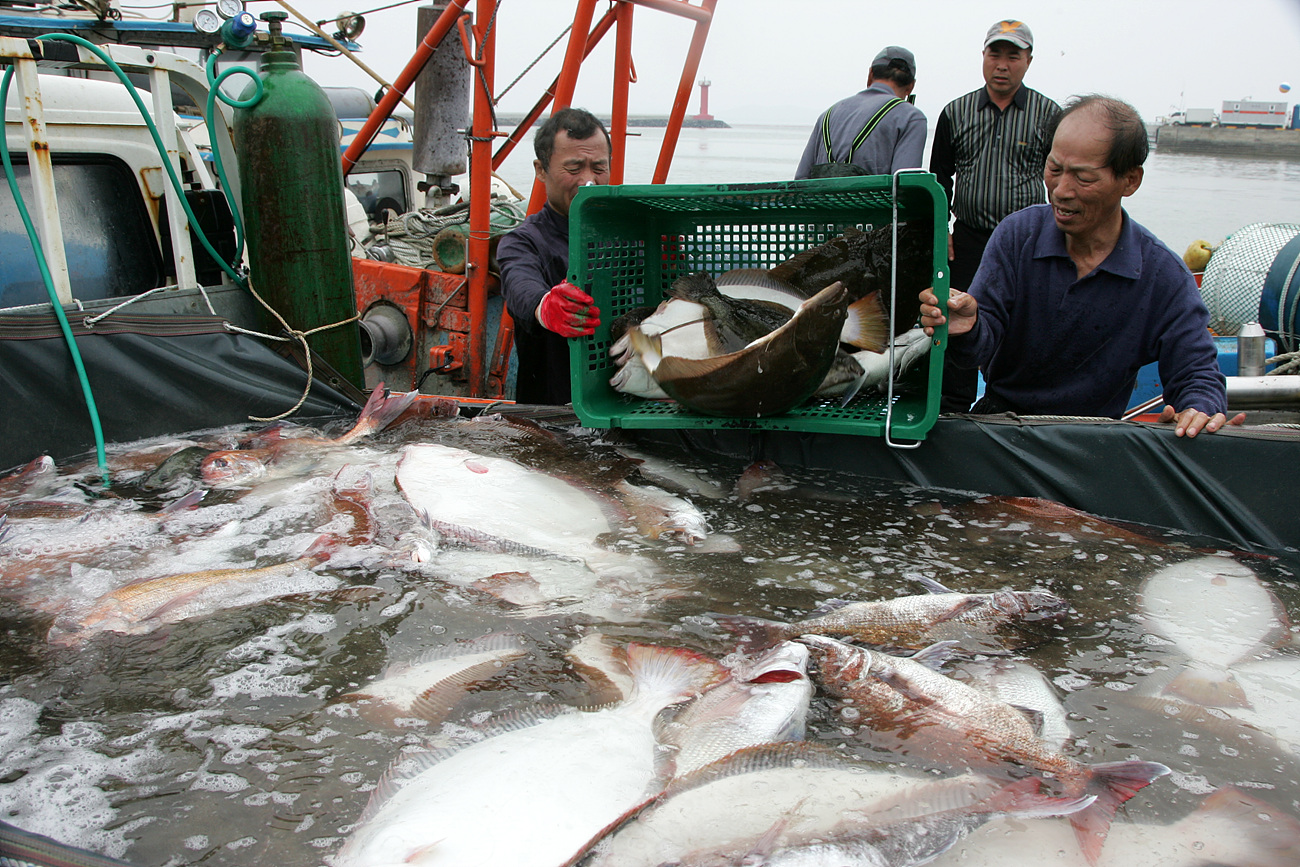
[343,0,718,398]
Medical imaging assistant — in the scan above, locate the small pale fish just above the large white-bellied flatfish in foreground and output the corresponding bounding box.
[338,633,525,725]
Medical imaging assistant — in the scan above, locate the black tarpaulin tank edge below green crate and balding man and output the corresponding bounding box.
[628,416,1300,549]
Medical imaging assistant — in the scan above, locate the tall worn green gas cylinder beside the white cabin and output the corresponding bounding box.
[234,12,365,387]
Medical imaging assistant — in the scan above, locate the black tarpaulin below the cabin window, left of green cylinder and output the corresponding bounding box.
[0,313,360,468]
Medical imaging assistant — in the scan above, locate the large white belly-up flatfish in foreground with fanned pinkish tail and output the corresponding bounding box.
[334,645,724,867]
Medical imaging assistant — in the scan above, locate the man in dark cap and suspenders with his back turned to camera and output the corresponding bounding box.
[794,45,926,179]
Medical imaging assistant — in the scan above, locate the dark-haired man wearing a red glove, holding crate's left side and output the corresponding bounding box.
[497,108,612,404]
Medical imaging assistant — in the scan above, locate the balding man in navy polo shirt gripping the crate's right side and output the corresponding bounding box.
[920,96,1244,437]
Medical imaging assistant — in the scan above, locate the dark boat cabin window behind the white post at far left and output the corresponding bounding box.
[0,153,163,307]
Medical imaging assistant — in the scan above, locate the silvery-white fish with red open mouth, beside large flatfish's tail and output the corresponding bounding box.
[659,641,813,777]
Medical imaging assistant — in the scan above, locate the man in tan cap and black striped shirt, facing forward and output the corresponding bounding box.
[930,21,1061,412]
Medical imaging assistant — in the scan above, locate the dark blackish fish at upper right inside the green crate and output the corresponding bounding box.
[770,222,935,337]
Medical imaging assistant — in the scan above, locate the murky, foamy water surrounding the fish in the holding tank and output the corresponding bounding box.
[0,421,1300,867]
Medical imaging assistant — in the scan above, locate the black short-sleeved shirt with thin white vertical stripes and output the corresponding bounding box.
[930,86,1061,231]
